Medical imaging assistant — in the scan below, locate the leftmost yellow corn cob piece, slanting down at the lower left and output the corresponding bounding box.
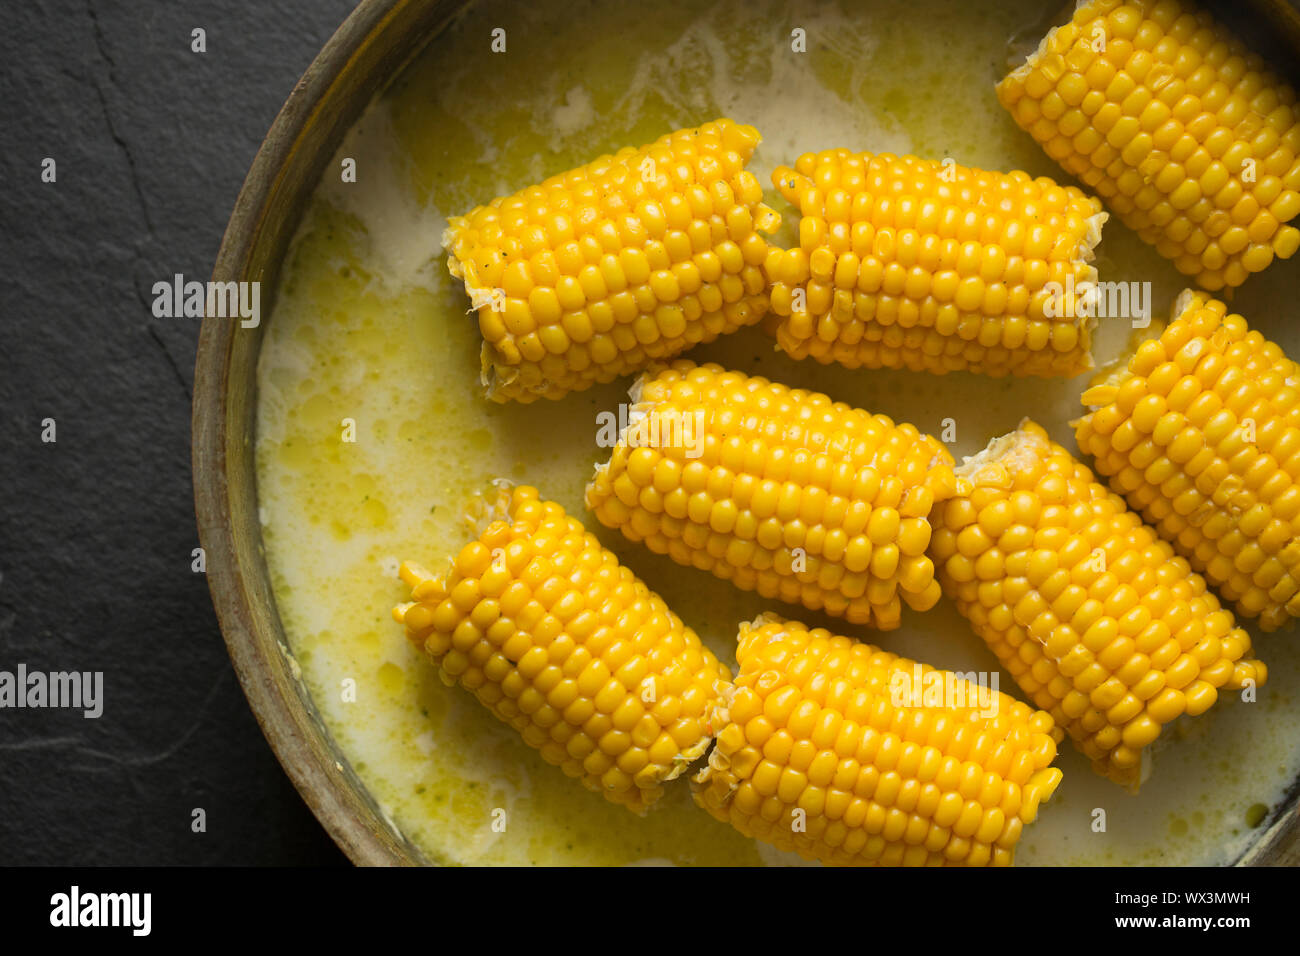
[393,486,731,813]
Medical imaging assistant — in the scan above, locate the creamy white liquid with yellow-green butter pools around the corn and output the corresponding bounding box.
[257,0,1300,865]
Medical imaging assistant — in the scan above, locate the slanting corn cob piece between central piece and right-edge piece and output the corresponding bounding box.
[931,419,1268,790]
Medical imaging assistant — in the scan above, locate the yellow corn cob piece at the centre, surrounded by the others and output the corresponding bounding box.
[586,359,954,630]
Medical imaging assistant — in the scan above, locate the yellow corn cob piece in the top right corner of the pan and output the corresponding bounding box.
[997,0,1300,290]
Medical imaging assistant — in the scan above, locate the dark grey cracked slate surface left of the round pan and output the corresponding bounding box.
[0,0,354,865]
